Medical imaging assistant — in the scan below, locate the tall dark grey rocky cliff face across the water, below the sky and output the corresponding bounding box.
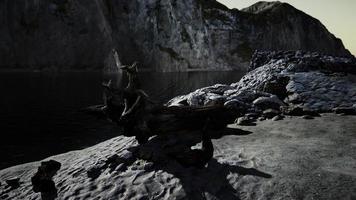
[0,0,351,71]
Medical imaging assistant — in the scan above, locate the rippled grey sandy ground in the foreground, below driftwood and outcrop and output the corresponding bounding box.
[0,114,356,200]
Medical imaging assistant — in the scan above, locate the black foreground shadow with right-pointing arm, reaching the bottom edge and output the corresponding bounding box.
[147,159,272,200]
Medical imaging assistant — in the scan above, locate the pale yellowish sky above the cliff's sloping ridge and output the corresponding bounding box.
[218,0,356,56]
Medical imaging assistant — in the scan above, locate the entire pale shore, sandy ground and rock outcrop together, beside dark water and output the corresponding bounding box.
[0,51,356,200]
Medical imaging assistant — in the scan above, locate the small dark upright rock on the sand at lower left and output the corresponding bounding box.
[31,160,61,196]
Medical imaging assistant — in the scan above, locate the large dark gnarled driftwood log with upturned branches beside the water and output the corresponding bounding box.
[87,63,236,143]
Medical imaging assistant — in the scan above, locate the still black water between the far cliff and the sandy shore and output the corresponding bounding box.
[0,72,243,169]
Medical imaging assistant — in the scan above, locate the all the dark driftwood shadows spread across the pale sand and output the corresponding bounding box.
[88,129,272,200]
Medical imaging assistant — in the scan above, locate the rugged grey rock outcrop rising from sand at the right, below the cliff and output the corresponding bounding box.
[167,51,356,120]
